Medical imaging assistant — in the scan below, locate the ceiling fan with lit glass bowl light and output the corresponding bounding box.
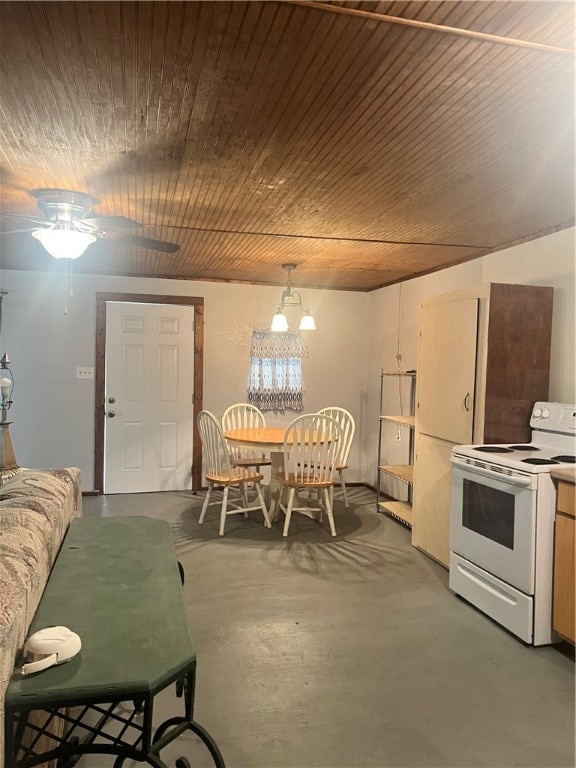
[0,189,180,259]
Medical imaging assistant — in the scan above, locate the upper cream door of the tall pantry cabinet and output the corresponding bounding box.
[416,299,478,444]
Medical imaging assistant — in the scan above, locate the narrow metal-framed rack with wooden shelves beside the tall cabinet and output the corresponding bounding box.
[377,371,416,527]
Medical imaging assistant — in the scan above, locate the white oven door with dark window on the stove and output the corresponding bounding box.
[450,455,537,595]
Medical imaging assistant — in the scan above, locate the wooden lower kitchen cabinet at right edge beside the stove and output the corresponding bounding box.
[552,470,576,644]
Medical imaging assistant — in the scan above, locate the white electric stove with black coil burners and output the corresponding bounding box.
[449,403,576,645]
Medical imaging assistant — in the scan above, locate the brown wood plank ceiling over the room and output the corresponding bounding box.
[0,0,575,291]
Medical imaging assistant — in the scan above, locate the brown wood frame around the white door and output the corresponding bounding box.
[94,293,204,493]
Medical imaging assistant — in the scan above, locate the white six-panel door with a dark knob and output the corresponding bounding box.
[104,302,194,493]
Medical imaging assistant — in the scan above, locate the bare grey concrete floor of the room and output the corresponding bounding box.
[79,488,575,768]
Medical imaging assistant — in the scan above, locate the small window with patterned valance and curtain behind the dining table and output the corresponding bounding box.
[248,328,308,411]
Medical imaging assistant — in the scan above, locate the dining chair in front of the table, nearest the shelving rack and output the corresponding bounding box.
[276,413,342,536]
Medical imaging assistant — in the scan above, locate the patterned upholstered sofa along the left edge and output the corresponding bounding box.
[0,467,82,765]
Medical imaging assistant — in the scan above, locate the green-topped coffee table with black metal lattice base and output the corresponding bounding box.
[5,517,224,768]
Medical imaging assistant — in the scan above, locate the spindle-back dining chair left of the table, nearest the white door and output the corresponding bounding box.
[198,411,271,536]
